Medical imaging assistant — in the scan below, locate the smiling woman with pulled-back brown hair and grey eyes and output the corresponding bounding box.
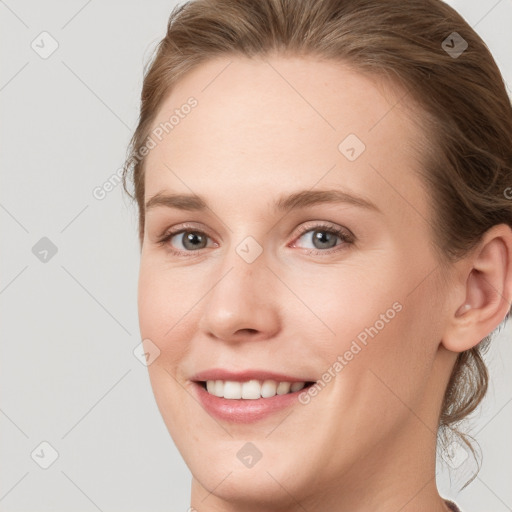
[125,0,512,512]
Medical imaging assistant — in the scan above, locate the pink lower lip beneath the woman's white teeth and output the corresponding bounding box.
[193,382,304,423]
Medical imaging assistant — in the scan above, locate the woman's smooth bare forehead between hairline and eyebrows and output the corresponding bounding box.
[145,57,427,224]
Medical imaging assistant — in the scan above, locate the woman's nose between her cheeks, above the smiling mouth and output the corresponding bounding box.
[199,250,281,343]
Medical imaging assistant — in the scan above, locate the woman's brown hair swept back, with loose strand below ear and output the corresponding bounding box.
[123,0,512,480]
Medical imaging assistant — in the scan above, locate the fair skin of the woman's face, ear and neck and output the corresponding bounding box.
[138,56,512,512]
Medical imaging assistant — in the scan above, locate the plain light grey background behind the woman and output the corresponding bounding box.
[0,0,512,512]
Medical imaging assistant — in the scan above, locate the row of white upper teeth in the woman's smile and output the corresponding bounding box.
[206,380,306,400]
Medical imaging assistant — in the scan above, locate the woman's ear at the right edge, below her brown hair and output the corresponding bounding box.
[442,224,512,352]
